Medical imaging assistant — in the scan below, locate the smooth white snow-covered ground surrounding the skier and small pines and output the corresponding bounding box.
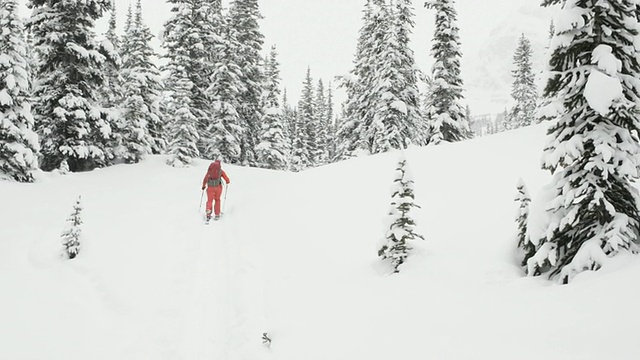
[0,126,640,360]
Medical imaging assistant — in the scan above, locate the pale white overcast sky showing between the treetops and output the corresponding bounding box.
[16,0,550,113]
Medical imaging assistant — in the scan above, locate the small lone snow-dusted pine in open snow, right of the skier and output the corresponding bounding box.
[378,156,424,273]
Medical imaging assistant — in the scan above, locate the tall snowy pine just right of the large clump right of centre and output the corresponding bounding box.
[425,0,468,145]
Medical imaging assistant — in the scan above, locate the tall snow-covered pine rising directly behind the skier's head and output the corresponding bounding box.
[203,1,244,164]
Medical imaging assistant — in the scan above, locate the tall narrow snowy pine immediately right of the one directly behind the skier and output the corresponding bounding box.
[229,0,264,165]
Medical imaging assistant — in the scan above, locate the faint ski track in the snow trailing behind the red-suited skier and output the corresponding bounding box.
[176,174,265,360]
